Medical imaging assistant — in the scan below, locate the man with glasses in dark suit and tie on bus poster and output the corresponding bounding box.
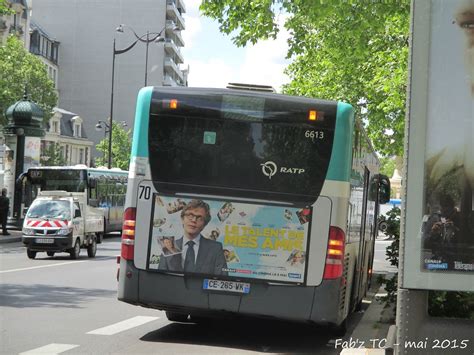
[158,200,227,275]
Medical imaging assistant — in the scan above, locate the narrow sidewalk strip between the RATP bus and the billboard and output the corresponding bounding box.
[341,274,394,355]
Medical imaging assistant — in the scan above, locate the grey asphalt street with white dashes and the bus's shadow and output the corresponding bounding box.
[0,236,392,354]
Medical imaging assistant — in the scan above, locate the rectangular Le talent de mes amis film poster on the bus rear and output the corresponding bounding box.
[149,195,311,283]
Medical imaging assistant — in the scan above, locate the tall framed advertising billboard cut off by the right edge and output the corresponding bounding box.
[403,0,474,291]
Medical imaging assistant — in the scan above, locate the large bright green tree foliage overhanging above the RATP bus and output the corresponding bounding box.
[200,0,410,155]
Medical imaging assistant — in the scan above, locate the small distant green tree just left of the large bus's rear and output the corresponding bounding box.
[95,122,132,170]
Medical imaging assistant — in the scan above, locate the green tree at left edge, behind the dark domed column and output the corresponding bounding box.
[0,36,58,124]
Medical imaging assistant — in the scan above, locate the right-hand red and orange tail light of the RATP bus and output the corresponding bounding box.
[323,226,346,280]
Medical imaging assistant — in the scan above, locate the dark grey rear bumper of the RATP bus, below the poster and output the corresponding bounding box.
[118,258,345,325]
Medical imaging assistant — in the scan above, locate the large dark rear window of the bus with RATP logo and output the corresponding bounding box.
[149,91,336,203]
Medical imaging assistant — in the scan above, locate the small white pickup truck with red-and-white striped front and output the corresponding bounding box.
[22,191,104,259]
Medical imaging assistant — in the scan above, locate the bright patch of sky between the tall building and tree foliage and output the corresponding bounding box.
[181,0,289,91]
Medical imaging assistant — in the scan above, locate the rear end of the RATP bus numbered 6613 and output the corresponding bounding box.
[118,87,353,325]
